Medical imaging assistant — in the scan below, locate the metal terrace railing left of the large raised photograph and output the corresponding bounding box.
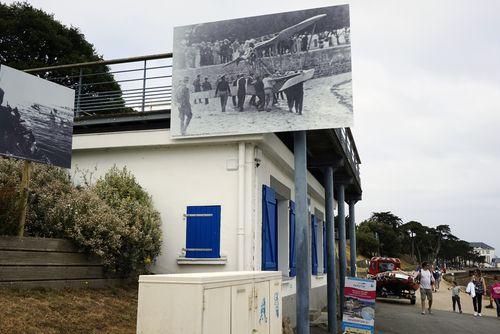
[26,53,172,116]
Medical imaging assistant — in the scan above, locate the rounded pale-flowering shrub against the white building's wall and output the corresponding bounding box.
[93,167,161,272]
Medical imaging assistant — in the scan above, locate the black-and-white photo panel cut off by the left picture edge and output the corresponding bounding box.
[0,65,75,168]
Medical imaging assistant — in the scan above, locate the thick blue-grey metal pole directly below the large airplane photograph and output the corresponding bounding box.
[293,131,311,334]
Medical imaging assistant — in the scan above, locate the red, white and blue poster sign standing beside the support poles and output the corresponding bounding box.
[342,277,377,334]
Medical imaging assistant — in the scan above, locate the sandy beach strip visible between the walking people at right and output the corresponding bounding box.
[417,280,497,317]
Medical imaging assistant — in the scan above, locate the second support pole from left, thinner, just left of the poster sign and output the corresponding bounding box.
[325,167,338,334]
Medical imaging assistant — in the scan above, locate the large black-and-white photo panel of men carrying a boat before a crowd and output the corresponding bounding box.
[171,5,353,138]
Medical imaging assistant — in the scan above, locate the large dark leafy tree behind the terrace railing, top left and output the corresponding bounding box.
[0,2,127,111]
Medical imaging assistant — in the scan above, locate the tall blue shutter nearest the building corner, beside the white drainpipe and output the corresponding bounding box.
[262,185,278,270]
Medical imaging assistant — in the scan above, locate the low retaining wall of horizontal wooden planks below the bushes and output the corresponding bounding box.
[0,237,120,288]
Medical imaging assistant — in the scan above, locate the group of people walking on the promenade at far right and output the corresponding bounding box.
[415,262,500,318]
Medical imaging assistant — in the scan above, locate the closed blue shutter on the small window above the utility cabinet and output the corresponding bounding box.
[186,205,221,258]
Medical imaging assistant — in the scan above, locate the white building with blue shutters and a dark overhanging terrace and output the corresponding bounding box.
[72,112,361,323]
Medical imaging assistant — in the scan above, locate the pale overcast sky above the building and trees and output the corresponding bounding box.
[3,0,500,255]
